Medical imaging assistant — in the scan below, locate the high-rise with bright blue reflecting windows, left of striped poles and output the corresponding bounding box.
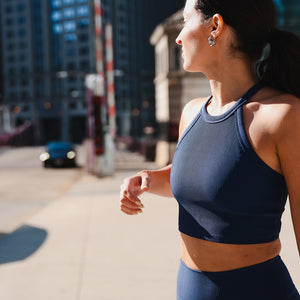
[0,0,95,143]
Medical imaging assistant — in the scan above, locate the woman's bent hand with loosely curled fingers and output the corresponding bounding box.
[120,171,151,215]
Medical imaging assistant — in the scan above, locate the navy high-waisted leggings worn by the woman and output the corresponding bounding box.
[177,256,300,300]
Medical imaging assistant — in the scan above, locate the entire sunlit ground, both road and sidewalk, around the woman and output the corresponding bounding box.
[0,147,300,300]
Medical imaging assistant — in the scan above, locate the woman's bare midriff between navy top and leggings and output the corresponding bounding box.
[181,233,281,272]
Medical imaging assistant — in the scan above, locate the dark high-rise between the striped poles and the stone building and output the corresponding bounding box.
[101,0,185,138]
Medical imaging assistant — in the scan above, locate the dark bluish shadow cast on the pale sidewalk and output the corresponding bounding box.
[0,225,48,264]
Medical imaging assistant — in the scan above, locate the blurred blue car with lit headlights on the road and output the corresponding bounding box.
[40,142,76,167]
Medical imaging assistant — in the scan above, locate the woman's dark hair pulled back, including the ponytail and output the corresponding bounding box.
[195,0,300,97]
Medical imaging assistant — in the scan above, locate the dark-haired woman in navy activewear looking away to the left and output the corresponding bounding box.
[120,0,300,300]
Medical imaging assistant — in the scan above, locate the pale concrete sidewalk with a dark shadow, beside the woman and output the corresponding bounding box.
[0,153,300,300]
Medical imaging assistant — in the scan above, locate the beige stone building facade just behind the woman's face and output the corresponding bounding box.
[150,10,210,166]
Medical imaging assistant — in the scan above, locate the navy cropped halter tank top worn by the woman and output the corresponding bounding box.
[170,84,287,244]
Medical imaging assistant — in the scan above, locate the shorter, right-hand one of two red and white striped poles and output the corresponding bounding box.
[105,23,116,136]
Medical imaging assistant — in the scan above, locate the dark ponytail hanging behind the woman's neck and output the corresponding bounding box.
[257,28,300,98]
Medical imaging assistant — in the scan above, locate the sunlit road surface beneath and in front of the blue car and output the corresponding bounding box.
[0,147,84,233]
